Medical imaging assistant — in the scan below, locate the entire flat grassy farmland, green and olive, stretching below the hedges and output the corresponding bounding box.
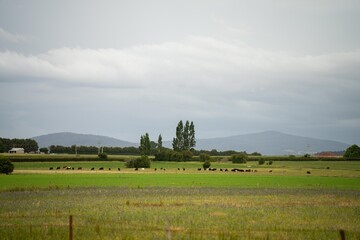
[0,158,360,239]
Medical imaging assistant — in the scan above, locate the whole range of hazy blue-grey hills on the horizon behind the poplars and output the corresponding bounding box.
[32,131,349,155]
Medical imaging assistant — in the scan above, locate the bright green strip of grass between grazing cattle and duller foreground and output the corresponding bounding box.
[0,172,360,191]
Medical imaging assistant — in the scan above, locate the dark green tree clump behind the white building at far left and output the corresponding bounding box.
[0,138,39,153]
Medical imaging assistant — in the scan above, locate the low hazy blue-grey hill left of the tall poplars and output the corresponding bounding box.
[32,132,139,147]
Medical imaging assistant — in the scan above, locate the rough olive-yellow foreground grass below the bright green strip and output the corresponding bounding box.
[0,188,360,239]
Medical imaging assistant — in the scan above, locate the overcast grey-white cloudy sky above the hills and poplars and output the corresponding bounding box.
[0,0,360,144]
